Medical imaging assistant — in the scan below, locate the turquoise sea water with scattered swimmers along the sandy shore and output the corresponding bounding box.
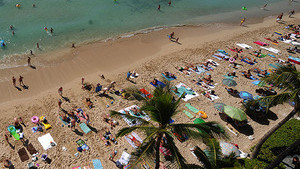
[0,0,300,58]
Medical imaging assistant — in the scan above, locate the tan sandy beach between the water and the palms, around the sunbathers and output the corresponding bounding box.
[0,14,300,169]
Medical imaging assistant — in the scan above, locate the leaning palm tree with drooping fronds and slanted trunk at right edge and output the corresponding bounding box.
[247,65,300,159]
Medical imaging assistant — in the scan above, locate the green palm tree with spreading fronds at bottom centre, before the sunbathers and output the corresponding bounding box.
[111,84,225,169]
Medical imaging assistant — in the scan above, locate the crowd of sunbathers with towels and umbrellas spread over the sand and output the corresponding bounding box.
[1,11,300,169]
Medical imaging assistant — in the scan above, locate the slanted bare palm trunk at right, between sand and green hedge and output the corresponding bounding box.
[250,105,299,159]
